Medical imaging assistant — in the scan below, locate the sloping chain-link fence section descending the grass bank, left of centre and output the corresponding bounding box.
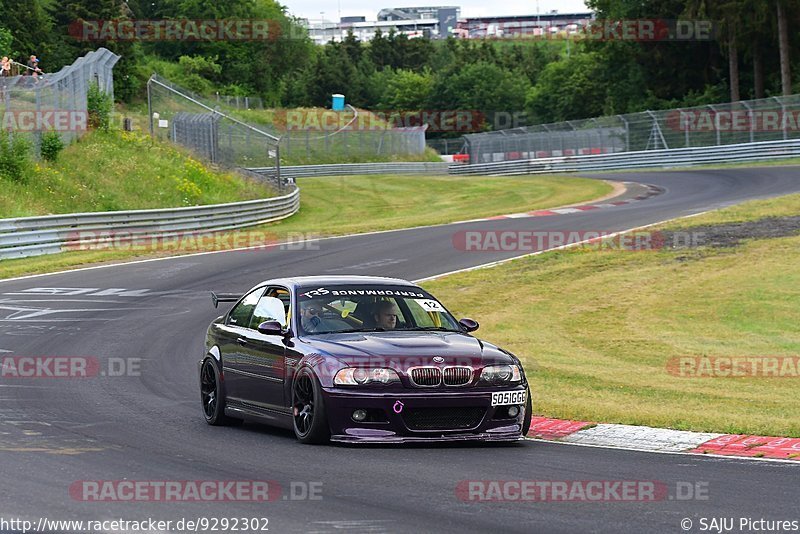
[147,74,286,188]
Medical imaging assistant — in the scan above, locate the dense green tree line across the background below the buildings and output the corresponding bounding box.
[0,0,800,129]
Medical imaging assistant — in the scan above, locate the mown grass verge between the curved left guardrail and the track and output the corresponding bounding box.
[0,175,612,278]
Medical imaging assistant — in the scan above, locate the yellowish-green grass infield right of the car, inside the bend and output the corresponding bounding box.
[424,195,800,436]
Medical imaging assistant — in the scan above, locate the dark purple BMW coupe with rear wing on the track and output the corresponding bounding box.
[200,276,531,443]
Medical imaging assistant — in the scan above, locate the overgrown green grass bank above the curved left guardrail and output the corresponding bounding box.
[0,131,274,218]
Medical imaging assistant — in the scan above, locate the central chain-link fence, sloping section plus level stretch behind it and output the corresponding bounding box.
[147,74,432,176]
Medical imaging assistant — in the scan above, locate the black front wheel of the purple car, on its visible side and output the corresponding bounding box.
[292,367,331,444]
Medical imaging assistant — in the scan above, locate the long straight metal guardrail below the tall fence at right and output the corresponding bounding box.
[448,139,800,176]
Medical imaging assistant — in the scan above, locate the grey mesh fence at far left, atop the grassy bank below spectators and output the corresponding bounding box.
[0,48,120,148]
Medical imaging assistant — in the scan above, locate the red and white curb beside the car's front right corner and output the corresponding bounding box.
[528,417,800,462]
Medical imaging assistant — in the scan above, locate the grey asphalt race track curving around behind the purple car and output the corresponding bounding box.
[0,167,800,533]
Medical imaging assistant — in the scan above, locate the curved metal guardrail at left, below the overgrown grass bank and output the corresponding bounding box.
[0,186,300,259]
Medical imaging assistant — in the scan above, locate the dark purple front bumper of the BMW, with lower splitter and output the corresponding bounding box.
[323,386,527,443]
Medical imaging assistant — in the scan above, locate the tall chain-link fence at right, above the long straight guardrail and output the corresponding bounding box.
[464,95,800,163]
